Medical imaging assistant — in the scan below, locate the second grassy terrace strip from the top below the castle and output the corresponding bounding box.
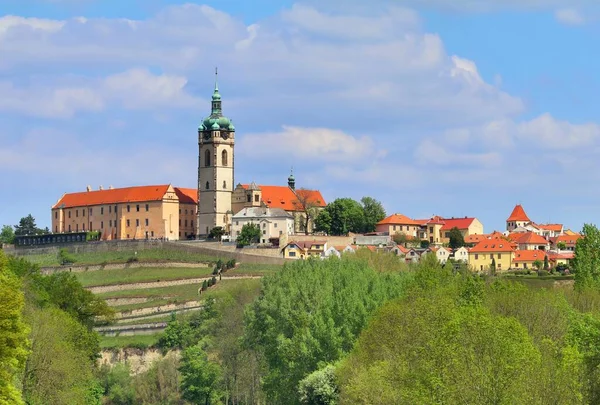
[73,267,212,287]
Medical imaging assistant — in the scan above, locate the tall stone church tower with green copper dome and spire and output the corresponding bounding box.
[196,69,235,237]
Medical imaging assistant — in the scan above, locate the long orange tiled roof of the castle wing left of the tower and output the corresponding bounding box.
[52,184,169,209]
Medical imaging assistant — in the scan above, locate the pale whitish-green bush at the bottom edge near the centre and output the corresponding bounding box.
[298,364,339,405]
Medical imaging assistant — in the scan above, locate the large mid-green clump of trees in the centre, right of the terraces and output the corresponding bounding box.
[246,255,410,404]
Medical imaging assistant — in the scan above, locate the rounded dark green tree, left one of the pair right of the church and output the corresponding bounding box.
[317,198,365,236]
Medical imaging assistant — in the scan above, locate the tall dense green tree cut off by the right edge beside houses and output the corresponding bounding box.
[573,224,600,290]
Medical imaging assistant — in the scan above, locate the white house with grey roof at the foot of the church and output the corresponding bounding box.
[231,207,294,243]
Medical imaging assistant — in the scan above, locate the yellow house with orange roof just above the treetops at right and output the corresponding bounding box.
[469,236,515,271]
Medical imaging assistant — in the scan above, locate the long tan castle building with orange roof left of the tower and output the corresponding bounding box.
[51,184,198,240]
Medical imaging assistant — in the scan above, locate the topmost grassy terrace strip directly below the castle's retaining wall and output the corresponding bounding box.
[18,248,218,267]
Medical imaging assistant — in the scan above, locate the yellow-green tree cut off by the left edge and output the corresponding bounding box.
[0,250,29,405]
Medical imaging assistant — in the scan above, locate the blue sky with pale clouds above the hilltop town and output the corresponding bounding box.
[0,0,600,232]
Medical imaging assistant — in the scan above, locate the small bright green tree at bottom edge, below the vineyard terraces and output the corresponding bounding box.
[179,344,222,405]
